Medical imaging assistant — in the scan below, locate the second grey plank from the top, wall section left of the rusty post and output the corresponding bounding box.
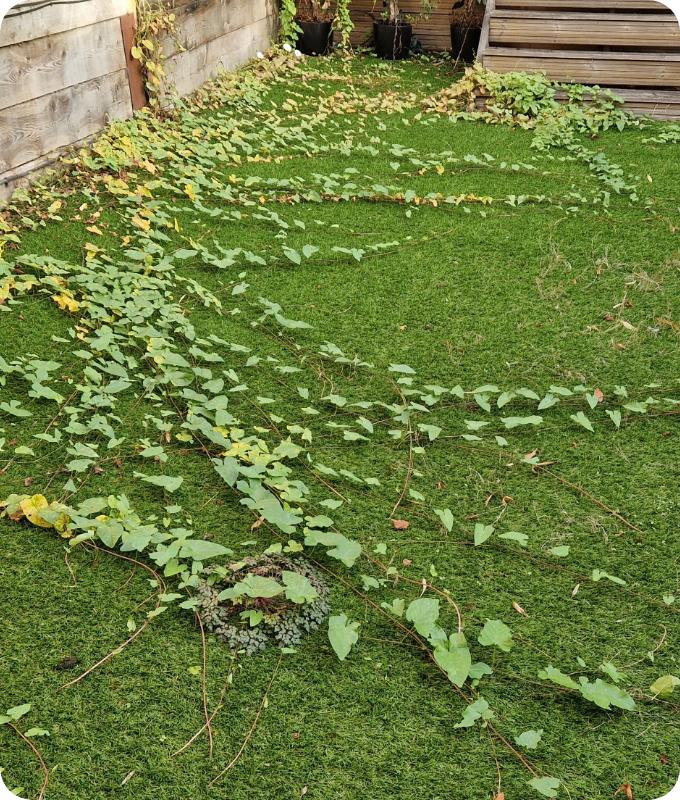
[0,18,125,109]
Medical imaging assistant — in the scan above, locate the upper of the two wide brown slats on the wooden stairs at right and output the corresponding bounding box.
[489,11,680,50]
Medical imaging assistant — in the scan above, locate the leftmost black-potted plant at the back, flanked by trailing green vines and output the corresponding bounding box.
[281,0,353,56]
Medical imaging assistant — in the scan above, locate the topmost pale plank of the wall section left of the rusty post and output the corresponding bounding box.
[0,0,135,47]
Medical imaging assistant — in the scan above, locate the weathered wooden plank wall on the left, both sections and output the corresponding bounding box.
[0,0,277,200]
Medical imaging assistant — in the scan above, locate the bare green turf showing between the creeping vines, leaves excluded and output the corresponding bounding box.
[0,54,680,800]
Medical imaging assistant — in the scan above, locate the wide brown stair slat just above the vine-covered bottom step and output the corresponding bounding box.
[484,47,680,87]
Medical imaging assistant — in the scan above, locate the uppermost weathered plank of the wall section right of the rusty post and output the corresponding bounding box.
[163,0,272,55]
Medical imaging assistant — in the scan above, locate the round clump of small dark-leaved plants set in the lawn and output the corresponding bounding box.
[196,554,329,655]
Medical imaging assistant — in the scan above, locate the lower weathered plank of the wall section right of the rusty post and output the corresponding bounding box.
[165,15,275,95]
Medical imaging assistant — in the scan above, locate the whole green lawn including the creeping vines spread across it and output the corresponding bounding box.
[0,55,680,800]
